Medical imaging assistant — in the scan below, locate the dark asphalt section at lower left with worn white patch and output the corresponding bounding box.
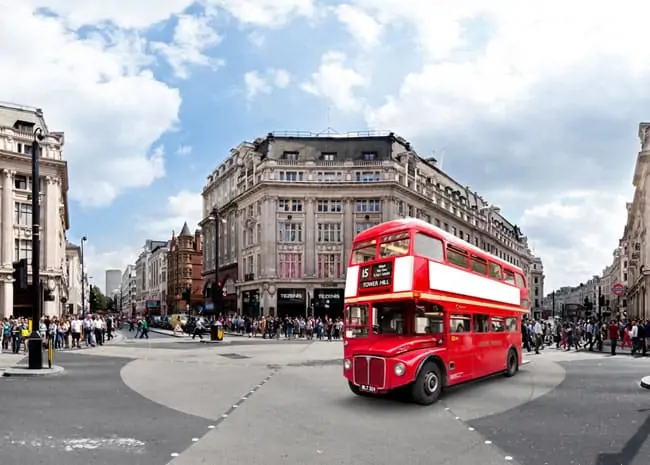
[0,353,209,465]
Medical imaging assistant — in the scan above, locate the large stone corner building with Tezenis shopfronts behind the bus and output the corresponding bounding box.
[201,132,533,316]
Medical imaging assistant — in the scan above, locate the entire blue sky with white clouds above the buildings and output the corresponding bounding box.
[0,0,650,289]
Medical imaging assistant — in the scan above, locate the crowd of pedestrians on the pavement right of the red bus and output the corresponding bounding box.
[522,319,650,356]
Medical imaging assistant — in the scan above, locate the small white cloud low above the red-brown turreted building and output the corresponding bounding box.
[139,189,203,240]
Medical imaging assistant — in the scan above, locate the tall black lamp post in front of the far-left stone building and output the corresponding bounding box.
[27,128,44,370]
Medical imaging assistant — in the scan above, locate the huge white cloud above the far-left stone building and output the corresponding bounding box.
[0,5,181,206]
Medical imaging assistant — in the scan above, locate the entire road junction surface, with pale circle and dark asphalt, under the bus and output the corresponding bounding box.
[5,336,650,465]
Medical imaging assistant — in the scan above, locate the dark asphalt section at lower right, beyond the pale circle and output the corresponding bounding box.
[471,355,650,465]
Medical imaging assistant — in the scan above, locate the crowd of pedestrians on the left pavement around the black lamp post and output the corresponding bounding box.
[0,314,120,354]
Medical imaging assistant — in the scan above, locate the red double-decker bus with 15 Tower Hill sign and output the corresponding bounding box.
[343,219,530,405]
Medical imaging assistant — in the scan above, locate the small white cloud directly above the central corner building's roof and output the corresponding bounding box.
[301,52,369,111]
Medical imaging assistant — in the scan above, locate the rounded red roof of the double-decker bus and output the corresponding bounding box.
[354,218,523,274]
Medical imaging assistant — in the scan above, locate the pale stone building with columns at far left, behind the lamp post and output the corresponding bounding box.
[0,103,70,317]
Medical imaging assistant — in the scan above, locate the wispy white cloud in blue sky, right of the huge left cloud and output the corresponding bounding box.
[151,15,225,79]
